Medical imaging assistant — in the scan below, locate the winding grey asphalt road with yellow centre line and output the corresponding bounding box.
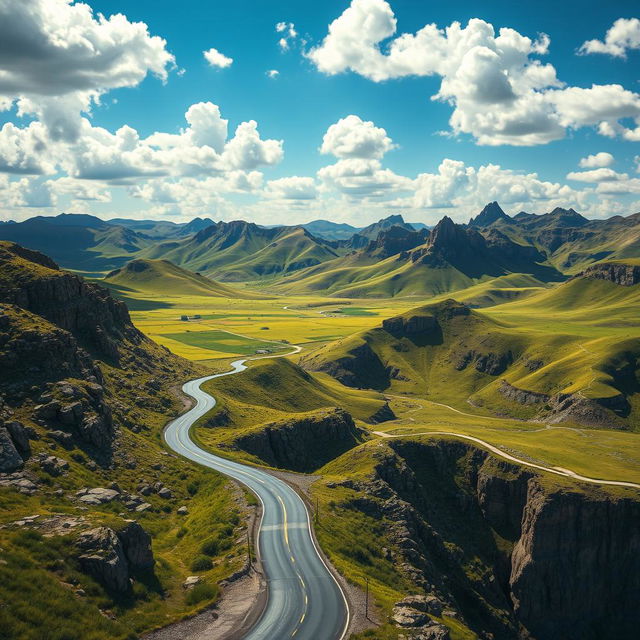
[164,356,349,640]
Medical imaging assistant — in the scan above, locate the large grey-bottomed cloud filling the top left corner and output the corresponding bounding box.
[0,0,175,140]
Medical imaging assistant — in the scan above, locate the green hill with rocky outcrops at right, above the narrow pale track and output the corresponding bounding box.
[303,265,640,429]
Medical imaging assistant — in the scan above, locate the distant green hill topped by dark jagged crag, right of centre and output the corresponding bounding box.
[275,217,563,298]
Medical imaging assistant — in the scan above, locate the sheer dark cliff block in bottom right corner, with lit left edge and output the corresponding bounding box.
[509,482,640,640]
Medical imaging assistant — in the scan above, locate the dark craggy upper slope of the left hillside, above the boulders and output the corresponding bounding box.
[0,242,198,462]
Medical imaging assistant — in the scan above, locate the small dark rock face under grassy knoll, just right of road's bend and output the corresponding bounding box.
[235,408,364,472]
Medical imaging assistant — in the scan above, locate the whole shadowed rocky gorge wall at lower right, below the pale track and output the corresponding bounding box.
[336,440,640,640]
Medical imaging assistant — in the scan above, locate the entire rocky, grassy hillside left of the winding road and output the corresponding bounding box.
[0,243,255,640]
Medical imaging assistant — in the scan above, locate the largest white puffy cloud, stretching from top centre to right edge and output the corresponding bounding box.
[306,0,640,146]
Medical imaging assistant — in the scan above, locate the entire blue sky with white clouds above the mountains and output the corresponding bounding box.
[0,0,640,224]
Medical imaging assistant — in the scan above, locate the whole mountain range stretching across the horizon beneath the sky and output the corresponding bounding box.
[0,202,640,297]
